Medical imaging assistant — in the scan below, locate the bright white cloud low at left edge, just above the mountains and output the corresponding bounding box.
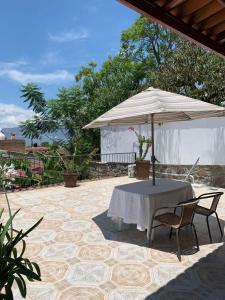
[0,103,33,128]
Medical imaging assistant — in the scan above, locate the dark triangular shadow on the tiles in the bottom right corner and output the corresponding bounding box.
[145,244,225,300]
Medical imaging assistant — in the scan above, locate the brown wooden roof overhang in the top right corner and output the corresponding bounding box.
[118,0,225,57]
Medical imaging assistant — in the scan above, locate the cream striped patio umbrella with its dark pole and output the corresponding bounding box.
[84,87,225,185]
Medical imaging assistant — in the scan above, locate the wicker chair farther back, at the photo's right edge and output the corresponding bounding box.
[195,192,223,243]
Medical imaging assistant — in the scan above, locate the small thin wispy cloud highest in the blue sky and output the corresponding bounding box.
[49,28,89,43]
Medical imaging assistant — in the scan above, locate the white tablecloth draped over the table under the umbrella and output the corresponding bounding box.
[107,179,193,230]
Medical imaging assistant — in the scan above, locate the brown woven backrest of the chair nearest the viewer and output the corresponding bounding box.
[177,198,199,226]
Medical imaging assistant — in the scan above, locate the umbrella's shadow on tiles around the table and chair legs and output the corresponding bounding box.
[93,211,225,255]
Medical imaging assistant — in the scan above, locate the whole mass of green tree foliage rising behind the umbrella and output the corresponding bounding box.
[19,17,225,155]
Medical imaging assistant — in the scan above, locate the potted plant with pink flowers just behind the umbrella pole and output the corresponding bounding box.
[128,127,152,180]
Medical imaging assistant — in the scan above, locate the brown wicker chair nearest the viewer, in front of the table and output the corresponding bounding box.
[149,199,199,261]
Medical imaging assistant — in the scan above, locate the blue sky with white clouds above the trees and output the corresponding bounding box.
[0,0,138,128]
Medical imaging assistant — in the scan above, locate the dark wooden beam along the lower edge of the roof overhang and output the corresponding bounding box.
[117,0,225,57]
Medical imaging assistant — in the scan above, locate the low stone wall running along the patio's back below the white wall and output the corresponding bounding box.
[88,163,225,187]
